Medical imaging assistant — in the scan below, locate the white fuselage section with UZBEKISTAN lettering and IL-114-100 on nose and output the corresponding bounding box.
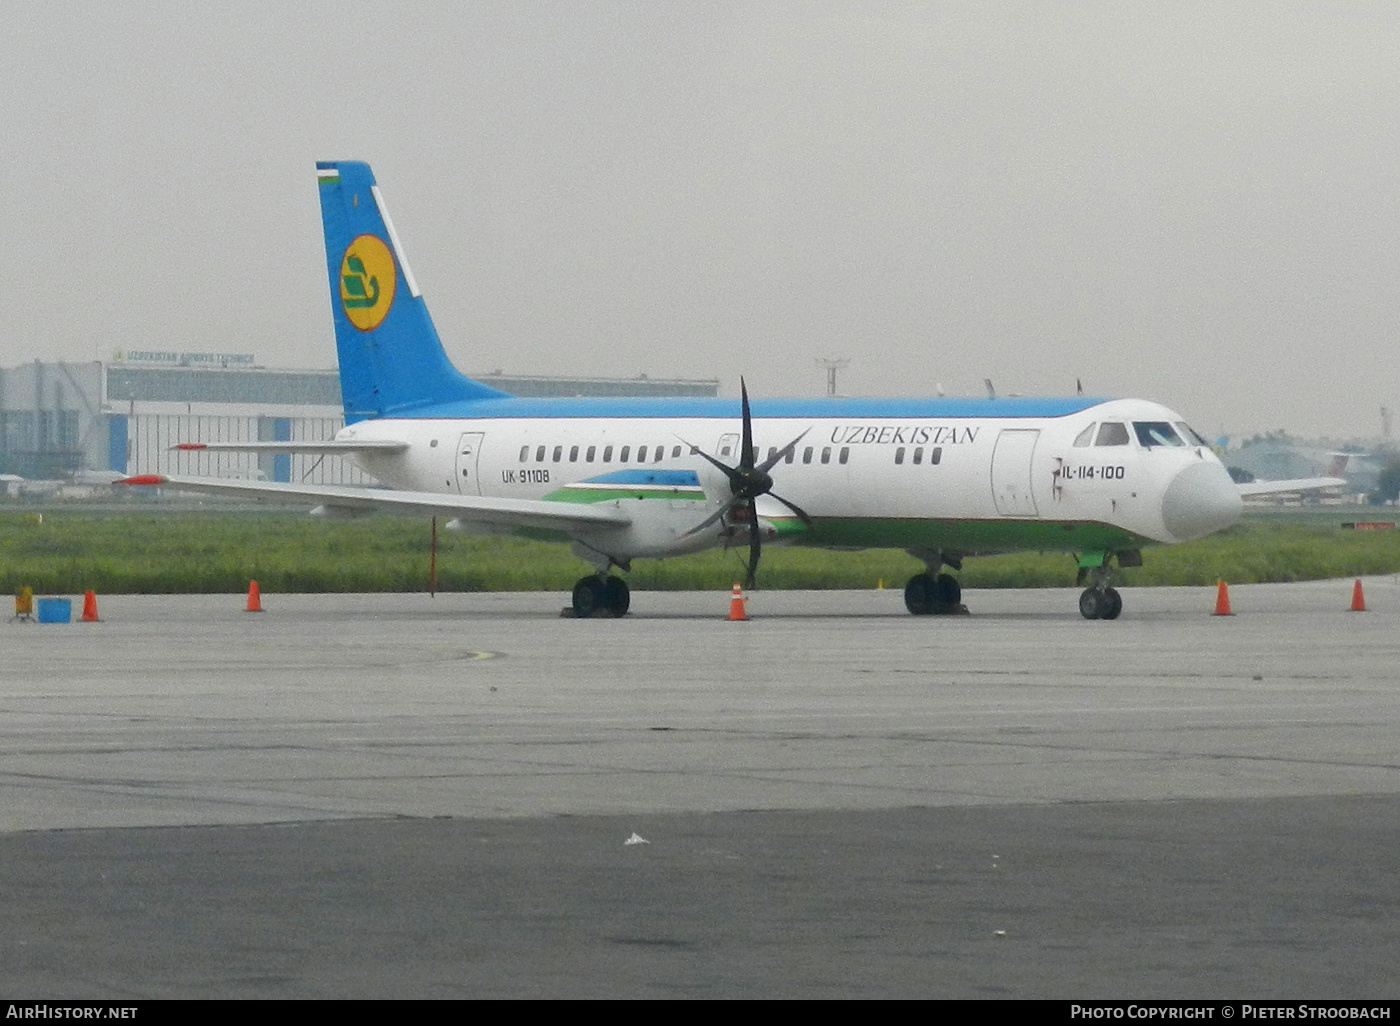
[339,399,1239,554]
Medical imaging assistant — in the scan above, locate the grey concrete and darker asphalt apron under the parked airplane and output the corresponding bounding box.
[0,578,1400,998]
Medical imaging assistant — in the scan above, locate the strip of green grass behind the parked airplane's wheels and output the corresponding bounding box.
[0,508,1400,593]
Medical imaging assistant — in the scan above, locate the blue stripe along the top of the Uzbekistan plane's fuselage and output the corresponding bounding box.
[375,396,1109,420]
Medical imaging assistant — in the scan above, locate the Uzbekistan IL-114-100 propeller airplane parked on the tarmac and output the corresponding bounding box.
[126,161,1340,620]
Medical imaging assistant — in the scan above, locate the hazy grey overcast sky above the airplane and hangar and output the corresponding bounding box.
[0,0,1400,437]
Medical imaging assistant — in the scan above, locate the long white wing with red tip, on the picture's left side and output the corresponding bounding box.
[118,475,631,530]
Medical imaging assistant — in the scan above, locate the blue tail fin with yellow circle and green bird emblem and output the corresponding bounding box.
[316,161,505,424]
